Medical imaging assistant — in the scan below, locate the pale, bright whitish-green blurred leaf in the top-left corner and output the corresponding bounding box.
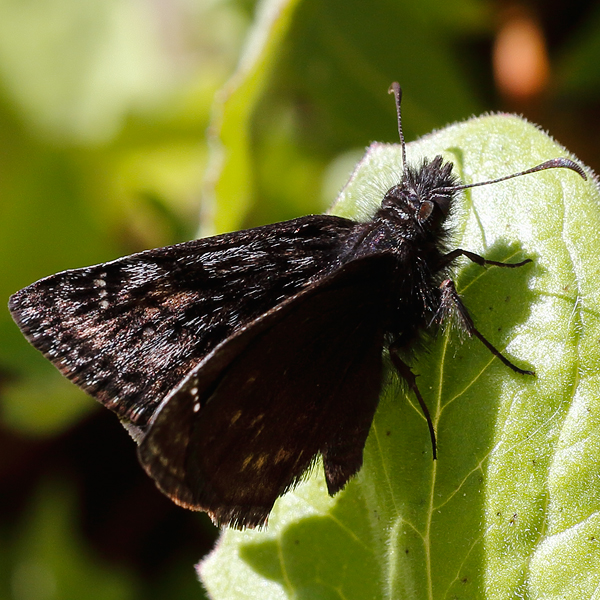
[0,0,175,142]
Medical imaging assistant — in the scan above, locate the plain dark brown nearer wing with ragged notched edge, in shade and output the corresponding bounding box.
[138,256,392,527]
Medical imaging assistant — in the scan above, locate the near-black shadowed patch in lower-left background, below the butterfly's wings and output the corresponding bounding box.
[0,410,218,598]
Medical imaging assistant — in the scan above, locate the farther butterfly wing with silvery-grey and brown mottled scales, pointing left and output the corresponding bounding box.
[9,215,356,436]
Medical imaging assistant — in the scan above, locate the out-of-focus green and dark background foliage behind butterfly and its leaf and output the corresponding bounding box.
[0,0,600,600]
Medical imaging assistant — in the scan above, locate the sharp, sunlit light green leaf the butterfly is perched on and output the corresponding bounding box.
[199,116,600,600]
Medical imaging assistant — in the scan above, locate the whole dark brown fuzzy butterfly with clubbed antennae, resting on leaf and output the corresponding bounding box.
[9,83,586,528]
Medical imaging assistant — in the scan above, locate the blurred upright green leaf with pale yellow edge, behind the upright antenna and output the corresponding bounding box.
[203,0,487,234]
